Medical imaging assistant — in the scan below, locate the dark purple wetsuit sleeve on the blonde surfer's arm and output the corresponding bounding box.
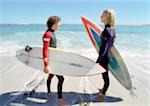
[99,30,114,58]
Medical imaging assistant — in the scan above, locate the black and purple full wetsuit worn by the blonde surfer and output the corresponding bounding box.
[96,25,116,94]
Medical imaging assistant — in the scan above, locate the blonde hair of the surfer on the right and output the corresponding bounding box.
[103,9,116,27]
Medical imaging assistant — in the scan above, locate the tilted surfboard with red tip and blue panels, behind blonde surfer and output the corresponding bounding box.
[81,16,132,90]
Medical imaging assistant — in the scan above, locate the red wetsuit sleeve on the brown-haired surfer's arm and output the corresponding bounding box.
[42,32,51,66]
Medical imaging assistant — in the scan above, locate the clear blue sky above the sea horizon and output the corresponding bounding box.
[0,0,150,25]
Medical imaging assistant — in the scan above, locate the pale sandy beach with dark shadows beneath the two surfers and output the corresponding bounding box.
[0,56,150,106]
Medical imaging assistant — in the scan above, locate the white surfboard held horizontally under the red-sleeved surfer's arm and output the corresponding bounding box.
[16,47,105,76]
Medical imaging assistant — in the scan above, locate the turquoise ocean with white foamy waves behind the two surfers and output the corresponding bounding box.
[0,24,150,74]
